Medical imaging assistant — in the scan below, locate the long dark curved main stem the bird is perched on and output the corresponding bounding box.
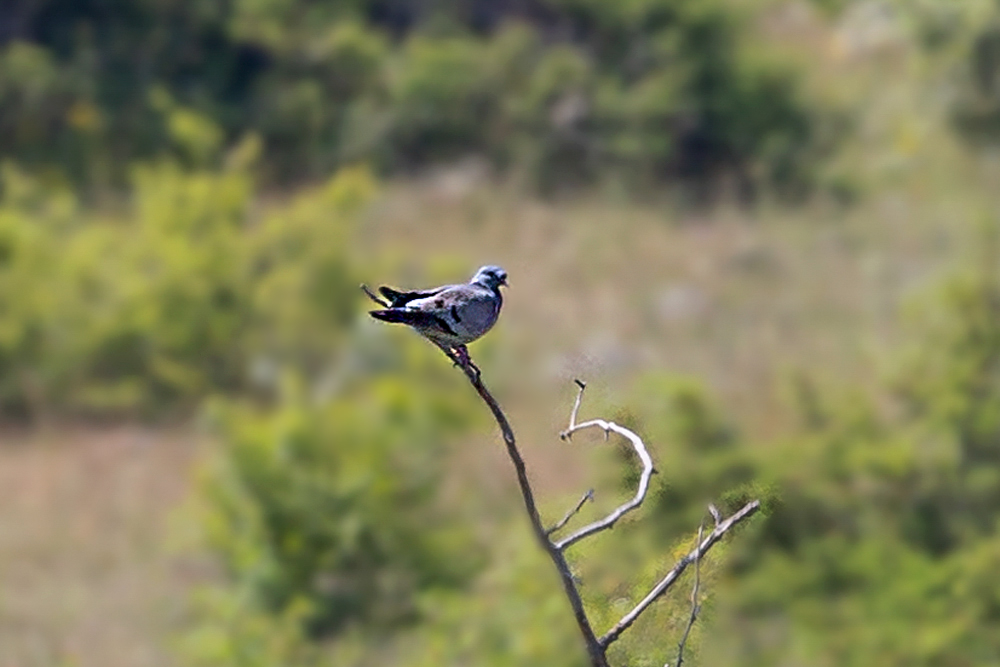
[452,354,610,667]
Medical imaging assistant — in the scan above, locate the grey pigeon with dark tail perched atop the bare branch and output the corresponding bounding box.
[369,265,507,365]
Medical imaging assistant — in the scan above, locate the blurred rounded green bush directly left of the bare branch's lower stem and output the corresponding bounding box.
[193,368,477,636]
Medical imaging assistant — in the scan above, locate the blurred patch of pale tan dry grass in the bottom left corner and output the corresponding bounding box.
[0,427,209,667]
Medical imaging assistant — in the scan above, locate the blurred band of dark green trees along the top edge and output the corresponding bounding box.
[0,0,832,194]
